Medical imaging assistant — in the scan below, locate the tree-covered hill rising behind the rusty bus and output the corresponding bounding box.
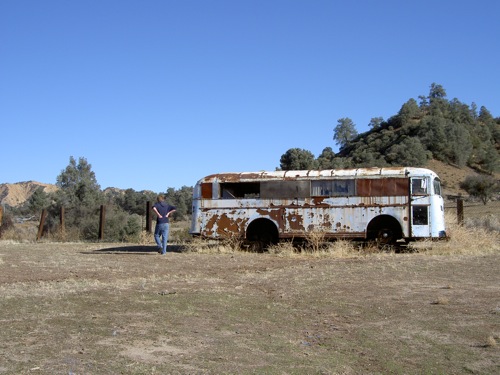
[280,83,500,174]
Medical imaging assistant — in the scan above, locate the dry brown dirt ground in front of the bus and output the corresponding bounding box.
[0,241,500,374]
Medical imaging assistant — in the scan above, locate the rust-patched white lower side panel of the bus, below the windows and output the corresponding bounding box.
[190,196,409,238]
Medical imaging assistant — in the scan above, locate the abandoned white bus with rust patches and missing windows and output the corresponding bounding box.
[190,167,446,247]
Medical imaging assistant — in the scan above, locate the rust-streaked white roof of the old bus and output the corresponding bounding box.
[198,167,437,183]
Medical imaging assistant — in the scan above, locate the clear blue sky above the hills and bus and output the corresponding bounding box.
[0,0,500,192]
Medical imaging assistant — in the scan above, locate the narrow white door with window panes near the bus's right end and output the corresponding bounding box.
[410,177,431,238]
